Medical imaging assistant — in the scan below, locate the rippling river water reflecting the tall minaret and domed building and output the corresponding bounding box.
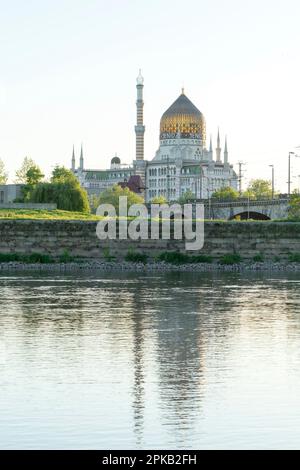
[0,272,300,449]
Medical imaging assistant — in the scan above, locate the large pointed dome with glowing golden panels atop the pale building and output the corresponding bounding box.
[160,90,206,145]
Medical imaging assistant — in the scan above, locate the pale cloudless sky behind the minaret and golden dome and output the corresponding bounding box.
[0,0,300,192]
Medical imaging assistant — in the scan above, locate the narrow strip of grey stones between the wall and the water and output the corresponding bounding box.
[0,260,300,272]
